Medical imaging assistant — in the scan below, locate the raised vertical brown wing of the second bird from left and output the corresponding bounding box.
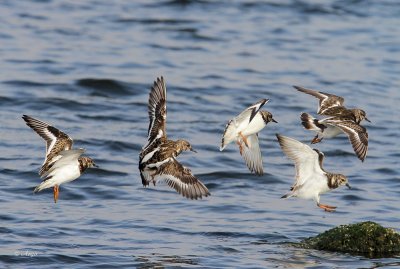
[147,77,167,144]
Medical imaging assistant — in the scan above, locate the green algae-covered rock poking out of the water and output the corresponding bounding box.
[300,221,400,258]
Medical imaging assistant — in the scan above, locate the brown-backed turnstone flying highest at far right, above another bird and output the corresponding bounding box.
[294,86,370,161]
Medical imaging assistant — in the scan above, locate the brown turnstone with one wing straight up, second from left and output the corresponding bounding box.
[139,77,210,199]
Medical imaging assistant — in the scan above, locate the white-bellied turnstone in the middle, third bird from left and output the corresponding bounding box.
[220,99,277,175]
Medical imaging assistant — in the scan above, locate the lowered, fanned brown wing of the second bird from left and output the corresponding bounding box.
[156,159,210,200]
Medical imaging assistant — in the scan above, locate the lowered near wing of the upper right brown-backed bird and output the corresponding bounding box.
[325,118,368,161]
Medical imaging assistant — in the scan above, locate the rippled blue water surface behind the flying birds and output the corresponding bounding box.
[0,0,400,268]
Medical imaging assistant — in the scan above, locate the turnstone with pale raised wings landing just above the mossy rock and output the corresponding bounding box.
[276,134,350,212]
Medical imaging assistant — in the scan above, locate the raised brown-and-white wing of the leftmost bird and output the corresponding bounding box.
[22,115,73,175]
